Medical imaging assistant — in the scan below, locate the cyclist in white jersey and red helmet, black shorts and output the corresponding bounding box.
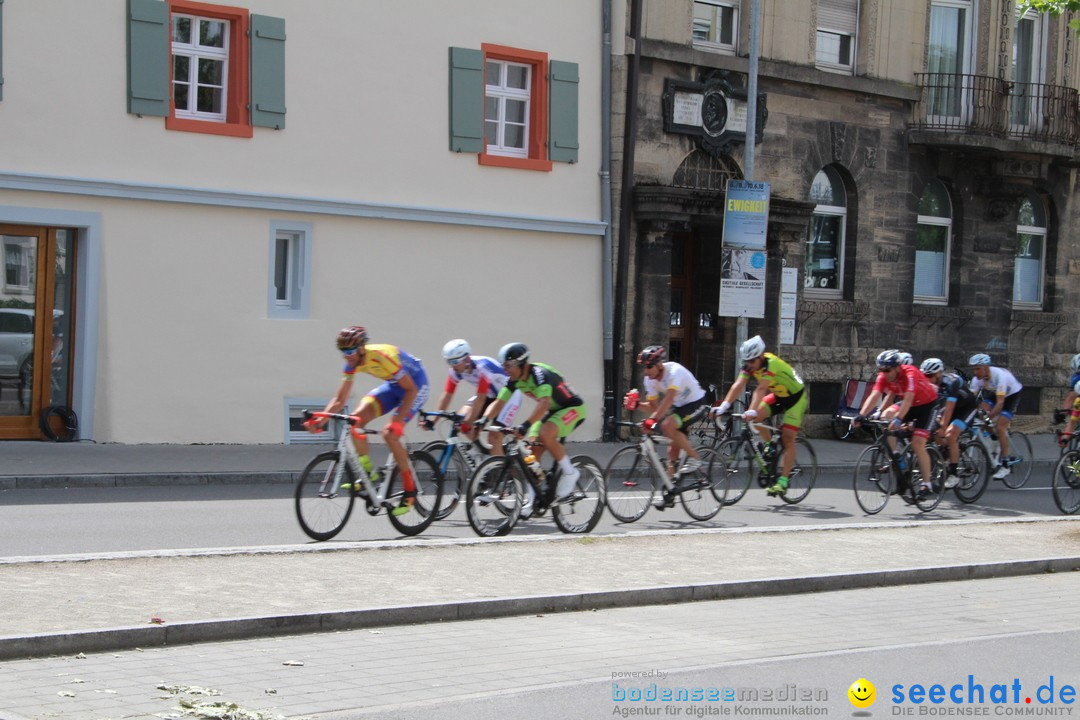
[623,345,708,508]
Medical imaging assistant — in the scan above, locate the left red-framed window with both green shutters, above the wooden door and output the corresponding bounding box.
[127,0,285,137]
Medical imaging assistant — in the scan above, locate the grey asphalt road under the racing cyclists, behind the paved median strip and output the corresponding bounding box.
[0,470,1059,557]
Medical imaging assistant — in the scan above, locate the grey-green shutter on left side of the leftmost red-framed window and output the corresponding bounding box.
[127,0,172,118]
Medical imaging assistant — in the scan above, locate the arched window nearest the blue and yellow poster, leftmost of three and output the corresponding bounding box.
[804,166,848,296]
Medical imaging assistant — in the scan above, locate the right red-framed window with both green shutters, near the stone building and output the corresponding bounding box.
[449,44,578,171]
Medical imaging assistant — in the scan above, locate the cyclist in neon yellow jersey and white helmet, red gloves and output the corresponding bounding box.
[714,335,810,497]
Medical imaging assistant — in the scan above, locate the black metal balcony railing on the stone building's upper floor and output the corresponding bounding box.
[912,72,1080,146]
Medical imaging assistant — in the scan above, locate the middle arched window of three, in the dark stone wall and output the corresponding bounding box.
[915,180,953,303]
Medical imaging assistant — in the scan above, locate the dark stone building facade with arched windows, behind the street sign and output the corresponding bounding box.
[612,0,1080,429]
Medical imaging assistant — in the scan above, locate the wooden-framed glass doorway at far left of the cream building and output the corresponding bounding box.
[0,225,76,439]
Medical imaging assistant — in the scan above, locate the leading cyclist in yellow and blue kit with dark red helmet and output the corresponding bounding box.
[308,325,428,515]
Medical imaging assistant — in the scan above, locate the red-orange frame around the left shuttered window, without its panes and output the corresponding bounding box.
[165,0,255,137]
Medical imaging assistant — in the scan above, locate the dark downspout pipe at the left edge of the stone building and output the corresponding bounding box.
[607,0,643,442]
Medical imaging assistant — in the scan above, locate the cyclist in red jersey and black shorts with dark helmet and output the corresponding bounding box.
[855,350,937,495]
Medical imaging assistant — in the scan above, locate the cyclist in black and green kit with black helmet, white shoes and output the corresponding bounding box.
[484,342,585,514]
